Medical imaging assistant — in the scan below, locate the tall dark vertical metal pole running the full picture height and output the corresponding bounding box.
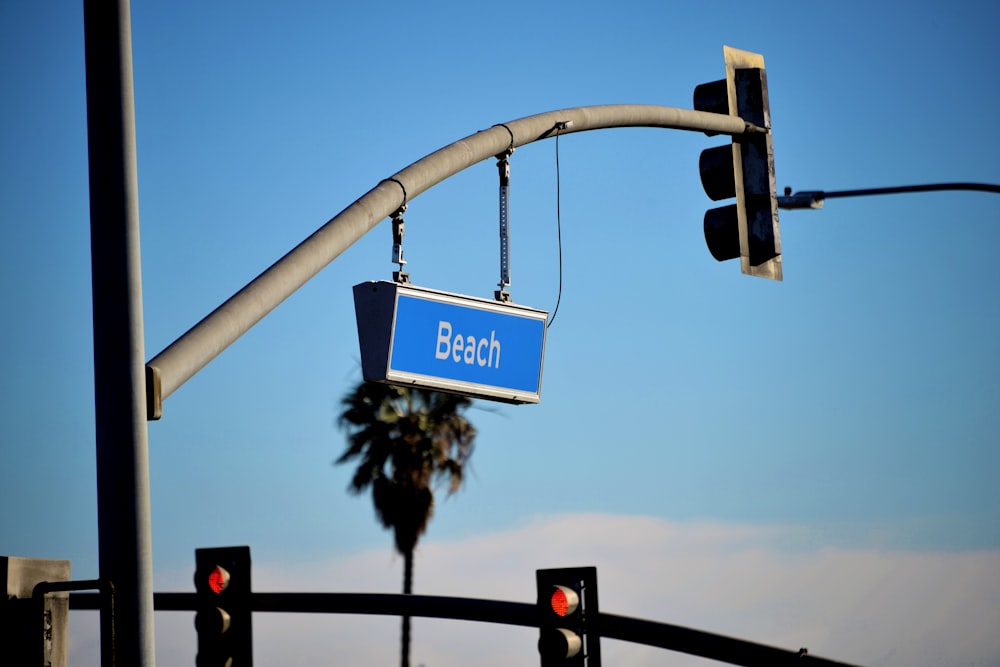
[83,0,155,667]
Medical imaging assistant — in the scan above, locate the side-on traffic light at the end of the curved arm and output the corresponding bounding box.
[694,46,781,280]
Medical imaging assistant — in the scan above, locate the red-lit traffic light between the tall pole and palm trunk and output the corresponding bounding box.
[194,547,253,667]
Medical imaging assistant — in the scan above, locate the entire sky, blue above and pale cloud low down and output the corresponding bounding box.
[0,0,1000,667]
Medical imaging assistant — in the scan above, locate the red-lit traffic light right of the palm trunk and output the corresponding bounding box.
[535,567,601,667]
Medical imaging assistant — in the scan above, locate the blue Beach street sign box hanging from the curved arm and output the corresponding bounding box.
[354,281,548,403]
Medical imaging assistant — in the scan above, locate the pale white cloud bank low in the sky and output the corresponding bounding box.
[71,514,1000,667]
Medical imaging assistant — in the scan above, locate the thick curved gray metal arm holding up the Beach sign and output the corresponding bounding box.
[147,104,761,419]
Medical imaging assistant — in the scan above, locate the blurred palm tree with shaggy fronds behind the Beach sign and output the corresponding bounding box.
[336,382,476,667]
